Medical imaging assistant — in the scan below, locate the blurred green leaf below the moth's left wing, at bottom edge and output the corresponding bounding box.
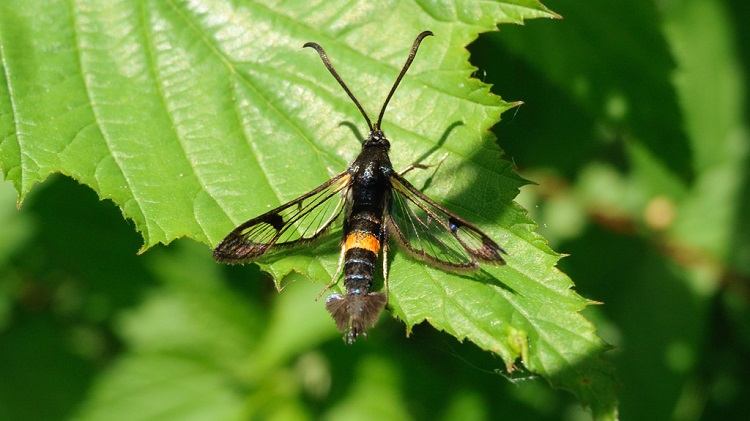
[77,245,336,420]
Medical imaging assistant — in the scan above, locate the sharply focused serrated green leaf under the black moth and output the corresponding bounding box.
[0,0,614,414]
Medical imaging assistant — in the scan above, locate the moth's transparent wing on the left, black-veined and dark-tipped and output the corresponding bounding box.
[214,172,350,263]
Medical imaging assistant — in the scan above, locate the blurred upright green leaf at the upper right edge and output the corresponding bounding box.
[665,1,750,276]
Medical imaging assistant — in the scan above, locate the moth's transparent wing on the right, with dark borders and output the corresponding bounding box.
[388,173,505,271]
